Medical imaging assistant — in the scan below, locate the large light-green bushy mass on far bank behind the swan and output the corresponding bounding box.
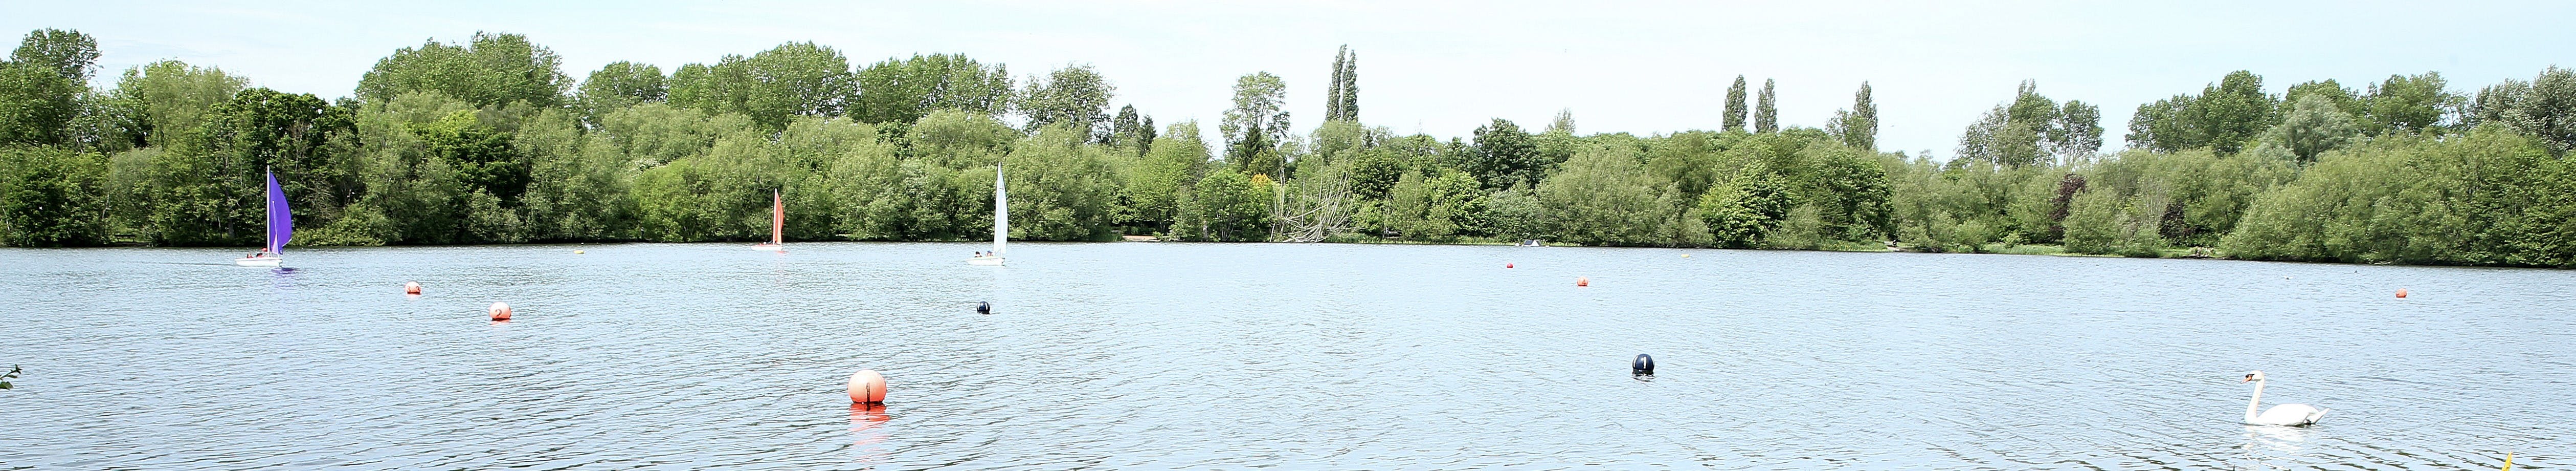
[2221,129,2576,268]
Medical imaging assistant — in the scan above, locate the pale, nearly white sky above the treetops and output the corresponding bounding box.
[0,0,2576,157]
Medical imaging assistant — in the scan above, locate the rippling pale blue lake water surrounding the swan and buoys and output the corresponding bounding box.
[0,242,2576,471]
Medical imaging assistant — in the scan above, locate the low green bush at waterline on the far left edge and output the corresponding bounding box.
[0,147,108,247]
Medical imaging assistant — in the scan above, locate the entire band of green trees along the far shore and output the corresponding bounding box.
[0,28,2576,268]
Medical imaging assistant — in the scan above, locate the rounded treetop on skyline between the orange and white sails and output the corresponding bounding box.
[850,54,1004,123]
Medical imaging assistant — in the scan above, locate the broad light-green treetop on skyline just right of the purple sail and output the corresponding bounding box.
[358,31,572,108]
